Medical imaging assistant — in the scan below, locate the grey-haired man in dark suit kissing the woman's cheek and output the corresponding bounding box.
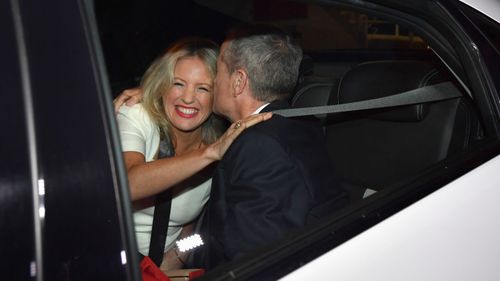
[194,26,347,269]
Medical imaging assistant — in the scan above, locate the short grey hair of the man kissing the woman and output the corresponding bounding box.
[222,25,302,102]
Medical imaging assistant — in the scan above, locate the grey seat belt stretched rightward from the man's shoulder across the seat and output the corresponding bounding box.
[273,82,462,117]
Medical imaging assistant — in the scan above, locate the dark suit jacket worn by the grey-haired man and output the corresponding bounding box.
[193,102,347,269]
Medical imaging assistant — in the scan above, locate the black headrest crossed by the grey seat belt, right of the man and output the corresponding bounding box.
[330,61,443,122]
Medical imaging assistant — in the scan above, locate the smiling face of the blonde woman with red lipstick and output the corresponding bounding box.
[162,57,213,135]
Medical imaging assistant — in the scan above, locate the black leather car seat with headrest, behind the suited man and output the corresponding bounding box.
[293,61,478,199]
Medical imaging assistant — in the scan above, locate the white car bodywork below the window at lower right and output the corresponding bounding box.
[282,156,500,281]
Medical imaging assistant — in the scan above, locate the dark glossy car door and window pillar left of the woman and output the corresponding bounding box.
[0,0,139,280]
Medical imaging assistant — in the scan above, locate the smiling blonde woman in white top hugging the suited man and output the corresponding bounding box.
[117,38,271,270]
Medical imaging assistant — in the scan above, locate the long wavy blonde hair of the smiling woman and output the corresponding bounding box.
[141,38,222,144]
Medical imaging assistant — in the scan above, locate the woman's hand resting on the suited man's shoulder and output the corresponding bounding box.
[206,112,273,160]
